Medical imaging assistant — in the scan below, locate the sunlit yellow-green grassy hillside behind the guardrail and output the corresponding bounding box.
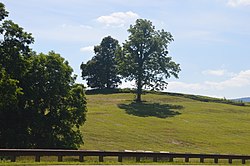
[81,93,250,154]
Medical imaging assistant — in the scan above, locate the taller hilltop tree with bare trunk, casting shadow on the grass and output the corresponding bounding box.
[119,19,181,102]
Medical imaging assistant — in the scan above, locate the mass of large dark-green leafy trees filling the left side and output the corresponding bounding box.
[0,3,86,149]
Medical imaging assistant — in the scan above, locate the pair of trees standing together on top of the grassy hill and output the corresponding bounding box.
[81,19,181,102]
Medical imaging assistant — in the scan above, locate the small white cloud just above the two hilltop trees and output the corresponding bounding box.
[97,11,139,26]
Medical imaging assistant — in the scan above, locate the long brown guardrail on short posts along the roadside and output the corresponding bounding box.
[0,149,250,164]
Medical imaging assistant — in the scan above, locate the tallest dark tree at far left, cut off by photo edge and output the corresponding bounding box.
[0,3,34,148]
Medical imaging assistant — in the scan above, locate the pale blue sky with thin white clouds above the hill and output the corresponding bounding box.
[2,0,250,98]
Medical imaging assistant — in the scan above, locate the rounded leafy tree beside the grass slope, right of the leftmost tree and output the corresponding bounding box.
[24,52,87,149]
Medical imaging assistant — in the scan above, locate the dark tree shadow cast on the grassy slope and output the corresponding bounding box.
[118,102,183,118]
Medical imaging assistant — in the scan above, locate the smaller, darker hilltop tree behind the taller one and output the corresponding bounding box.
[81,36,121,89]
